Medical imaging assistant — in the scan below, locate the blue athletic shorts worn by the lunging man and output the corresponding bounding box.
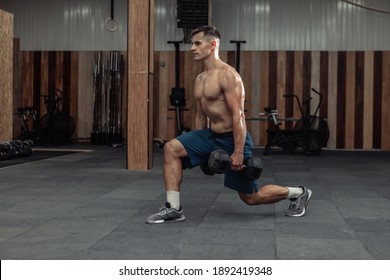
[176,128,259,193]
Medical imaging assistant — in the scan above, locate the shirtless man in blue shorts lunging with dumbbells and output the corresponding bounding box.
[146,26,312,224]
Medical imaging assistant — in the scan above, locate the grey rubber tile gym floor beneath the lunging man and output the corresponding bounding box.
[0,145,390,260]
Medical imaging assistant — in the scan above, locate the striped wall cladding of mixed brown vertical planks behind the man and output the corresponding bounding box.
[12,51,390,150]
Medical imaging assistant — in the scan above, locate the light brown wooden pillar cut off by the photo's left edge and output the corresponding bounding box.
[0,10,14,143]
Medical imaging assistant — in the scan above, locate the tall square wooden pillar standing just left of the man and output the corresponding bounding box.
[127,0,154,170]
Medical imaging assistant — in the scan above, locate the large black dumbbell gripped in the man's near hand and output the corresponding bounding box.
[200,150,263,180]
